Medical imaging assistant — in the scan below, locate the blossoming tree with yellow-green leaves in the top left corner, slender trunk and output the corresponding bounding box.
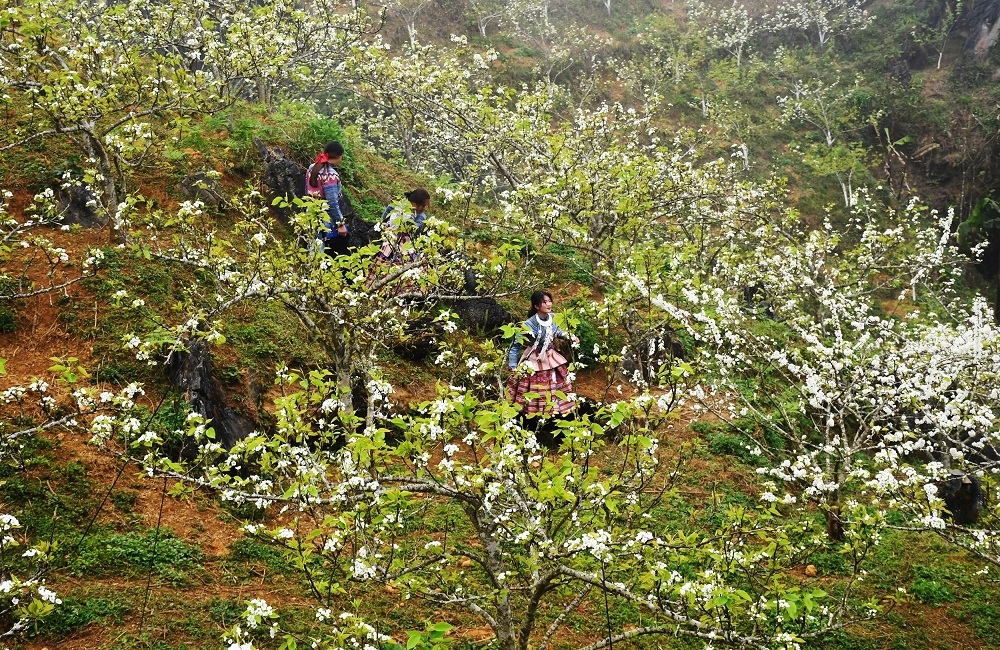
[0,0,369,237]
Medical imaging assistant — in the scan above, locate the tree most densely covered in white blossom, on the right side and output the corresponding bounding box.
[692,195,986,539]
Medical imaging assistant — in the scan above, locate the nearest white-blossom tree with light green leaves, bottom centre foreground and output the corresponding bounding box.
[94,358,872,650]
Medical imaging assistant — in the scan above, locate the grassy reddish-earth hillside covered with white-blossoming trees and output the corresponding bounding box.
[0,1,1000,650]
